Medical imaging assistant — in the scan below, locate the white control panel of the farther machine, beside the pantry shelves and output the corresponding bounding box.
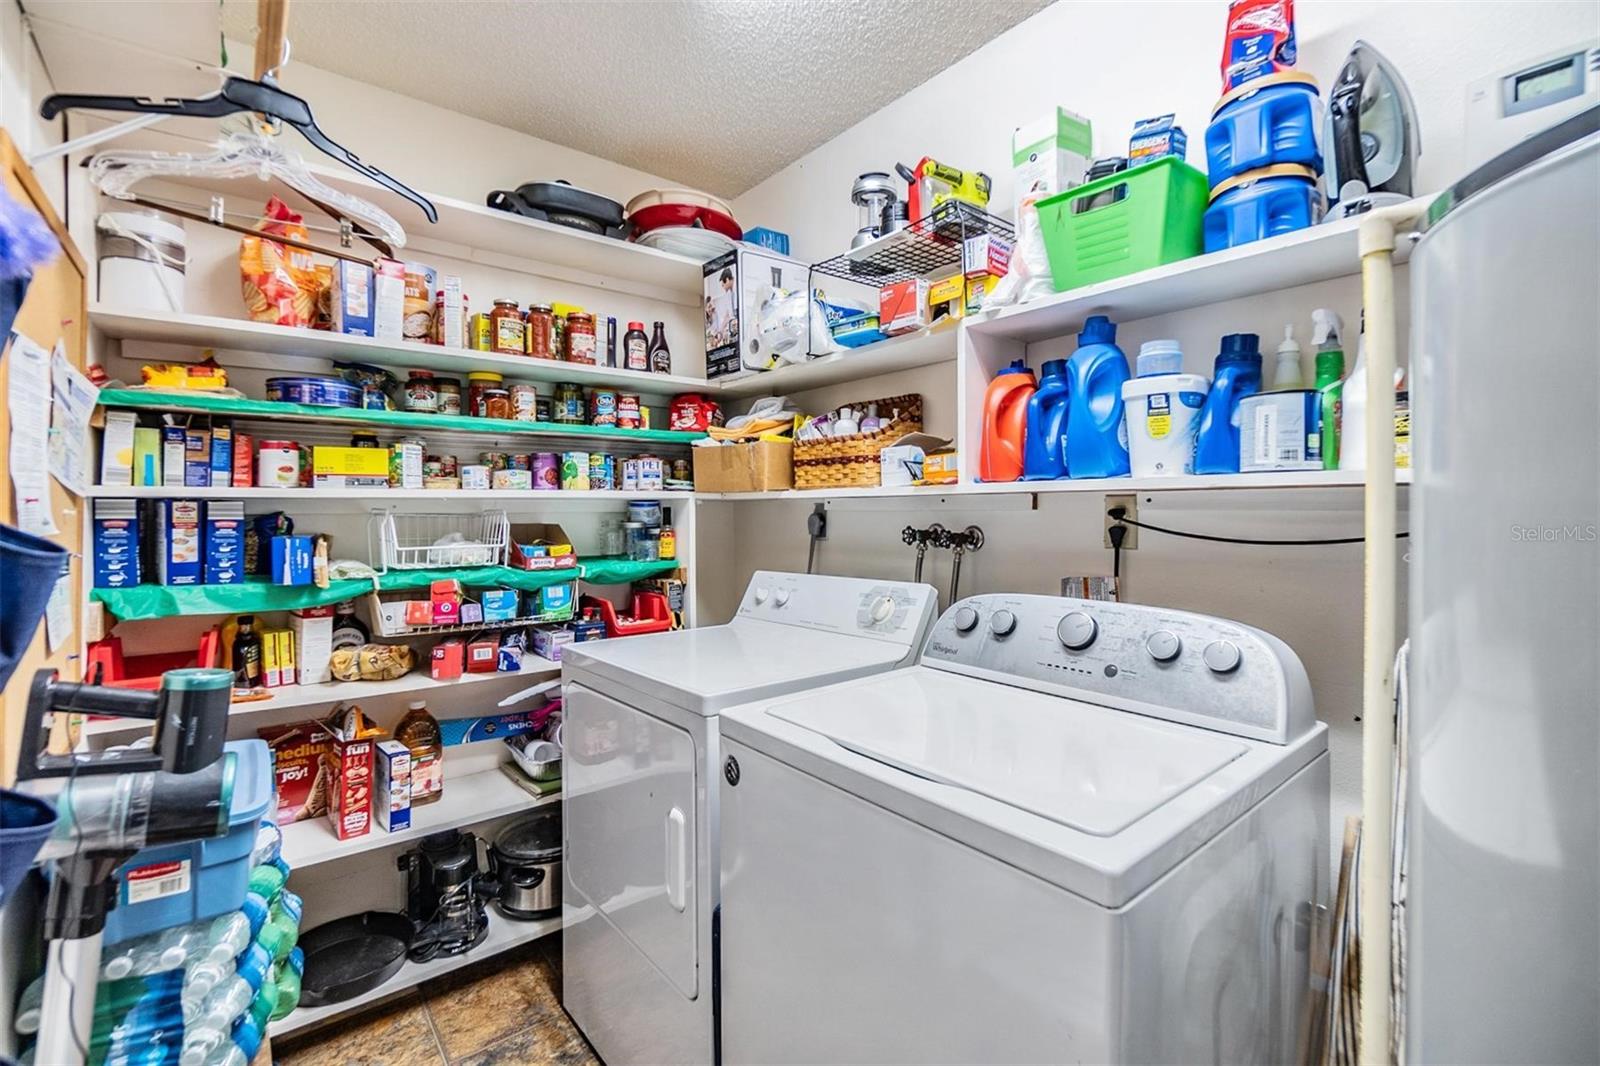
[739,570,939,648]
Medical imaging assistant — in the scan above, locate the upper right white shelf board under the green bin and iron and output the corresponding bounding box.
[966,200,1421,341]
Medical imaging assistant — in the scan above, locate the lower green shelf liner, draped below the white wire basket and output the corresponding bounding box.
[90,555,678,621]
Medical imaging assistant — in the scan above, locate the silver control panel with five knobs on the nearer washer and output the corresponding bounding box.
[922,594,1315,744]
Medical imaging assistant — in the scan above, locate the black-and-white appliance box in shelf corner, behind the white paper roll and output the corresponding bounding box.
[701,246,811,379]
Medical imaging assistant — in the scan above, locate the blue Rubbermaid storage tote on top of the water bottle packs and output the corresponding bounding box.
[106,739,272,944]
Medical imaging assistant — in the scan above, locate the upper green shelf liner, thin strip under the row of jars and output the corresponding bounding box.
[99,389,706,443]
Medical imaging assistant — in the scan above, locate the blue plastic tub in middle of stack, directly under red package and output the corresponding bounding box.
[1205,70,1322,189]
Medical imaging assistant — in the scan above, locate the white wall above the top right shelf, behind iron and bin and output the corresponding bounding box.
[733,0,1600,261]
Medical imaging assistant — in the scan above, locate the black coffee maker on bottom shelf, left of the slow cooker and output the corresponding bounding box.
[398,829,494,962]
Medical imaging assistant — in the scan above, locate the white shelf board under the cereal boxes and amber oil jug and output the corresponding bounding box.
[283,767,562,869]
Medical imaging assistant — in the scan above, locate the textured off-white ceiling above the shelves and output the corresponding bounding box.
[216,0,1050,195]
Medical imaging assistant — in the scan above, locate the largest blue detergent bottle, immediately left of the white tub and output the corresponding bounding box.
[1067,315,1131,477]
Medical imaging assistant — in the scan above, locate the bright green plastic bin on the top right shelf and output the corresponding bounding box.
[1037,155,1206,293]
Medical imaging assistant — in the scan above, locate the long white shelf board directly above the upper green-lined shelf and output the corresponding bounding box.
[90,304,706,395]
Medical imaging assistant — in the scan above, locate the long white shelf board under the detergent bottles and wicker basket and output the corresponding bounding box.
[710,471,1411,501]
